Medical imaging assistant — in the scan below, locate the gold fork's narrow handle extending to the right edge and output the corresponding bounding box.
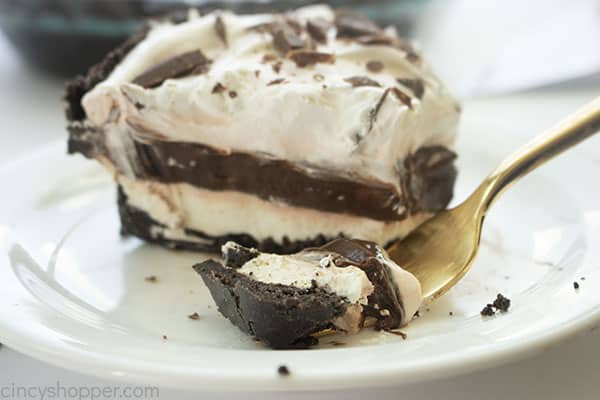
[476,97,600,212]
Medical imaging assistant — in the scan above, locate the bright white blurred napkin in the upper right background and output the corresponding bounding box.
[416,0,600,98]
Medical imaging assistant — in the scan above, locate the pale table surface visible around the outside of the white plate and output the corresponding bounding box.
[0,32,600,400]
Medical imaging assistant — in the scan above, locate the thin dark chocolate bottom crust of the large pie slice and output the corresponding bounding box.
[117,186,342,254]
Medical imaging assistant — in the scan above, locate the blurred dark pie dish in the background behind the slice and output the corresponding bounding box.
[0,0,424,77]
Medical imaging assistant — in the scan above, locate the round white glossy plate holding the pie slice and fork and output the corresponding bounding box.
[0,101,600,390]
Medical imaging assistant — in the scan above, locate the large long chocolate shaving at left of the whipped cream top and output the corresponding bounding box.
[133,50,210,88]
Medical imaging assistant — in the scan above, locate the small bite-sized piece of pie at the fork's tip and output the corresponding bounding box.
[194,239,421,348]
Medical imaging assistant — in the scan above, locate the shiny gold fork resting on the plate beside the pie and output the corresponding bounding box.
[388,97,600,301]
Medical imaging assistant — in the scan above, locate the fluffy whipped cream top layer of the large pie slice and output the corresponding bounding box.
[83,6,459,191]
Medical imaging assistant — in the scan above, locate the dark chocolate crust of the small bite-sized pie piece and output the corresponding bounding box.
[194,260,348,349]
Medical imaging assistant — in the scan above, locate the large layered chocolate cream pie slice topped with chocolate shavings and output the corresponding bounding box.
[66,6,460,253]
